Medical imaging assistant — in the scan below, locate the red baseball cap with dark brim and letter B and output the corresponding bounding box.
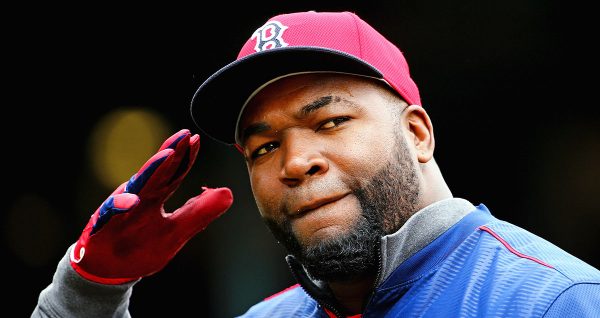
[190,11,421,145]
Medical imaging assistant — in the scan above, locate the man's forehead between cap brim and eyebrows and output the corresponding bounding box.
[238,73,392,124]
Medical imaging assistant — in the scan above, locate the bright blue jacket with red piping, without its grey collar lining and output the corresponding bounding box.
[242,204,600,318]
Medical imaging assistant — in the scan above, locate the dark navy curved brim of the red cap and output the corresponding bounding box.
[190,46,382,145]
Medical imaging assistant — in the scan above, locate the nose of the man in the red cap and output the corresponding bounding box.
[279,134,329,187]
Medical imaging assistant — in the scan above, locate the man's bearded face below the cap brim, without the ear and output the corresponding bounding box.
[239,74,418,280]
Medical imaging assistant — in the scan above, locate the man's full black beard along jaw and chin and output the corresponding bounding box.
[264,134,419,282]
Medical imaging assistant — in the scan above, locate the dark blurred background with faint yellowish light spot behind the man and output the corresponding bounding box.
[5,0,600,317]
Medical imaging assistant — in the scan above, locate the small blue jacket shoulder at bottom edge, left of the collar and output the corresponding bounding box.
[240,284,321,318]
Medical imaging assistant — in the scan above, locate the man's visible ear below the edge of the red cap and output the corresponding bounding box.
[403,105,435,163]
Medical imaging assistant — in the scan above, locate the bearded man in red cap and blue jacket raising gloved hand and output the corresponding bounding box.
[33,12,600,317]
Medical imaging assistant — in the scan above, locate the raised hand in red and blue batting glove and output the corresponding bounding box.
[71,129,233,284]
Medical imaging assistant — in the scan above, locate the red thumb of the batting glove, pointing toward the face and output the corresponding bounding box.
[169,187,233,235]
